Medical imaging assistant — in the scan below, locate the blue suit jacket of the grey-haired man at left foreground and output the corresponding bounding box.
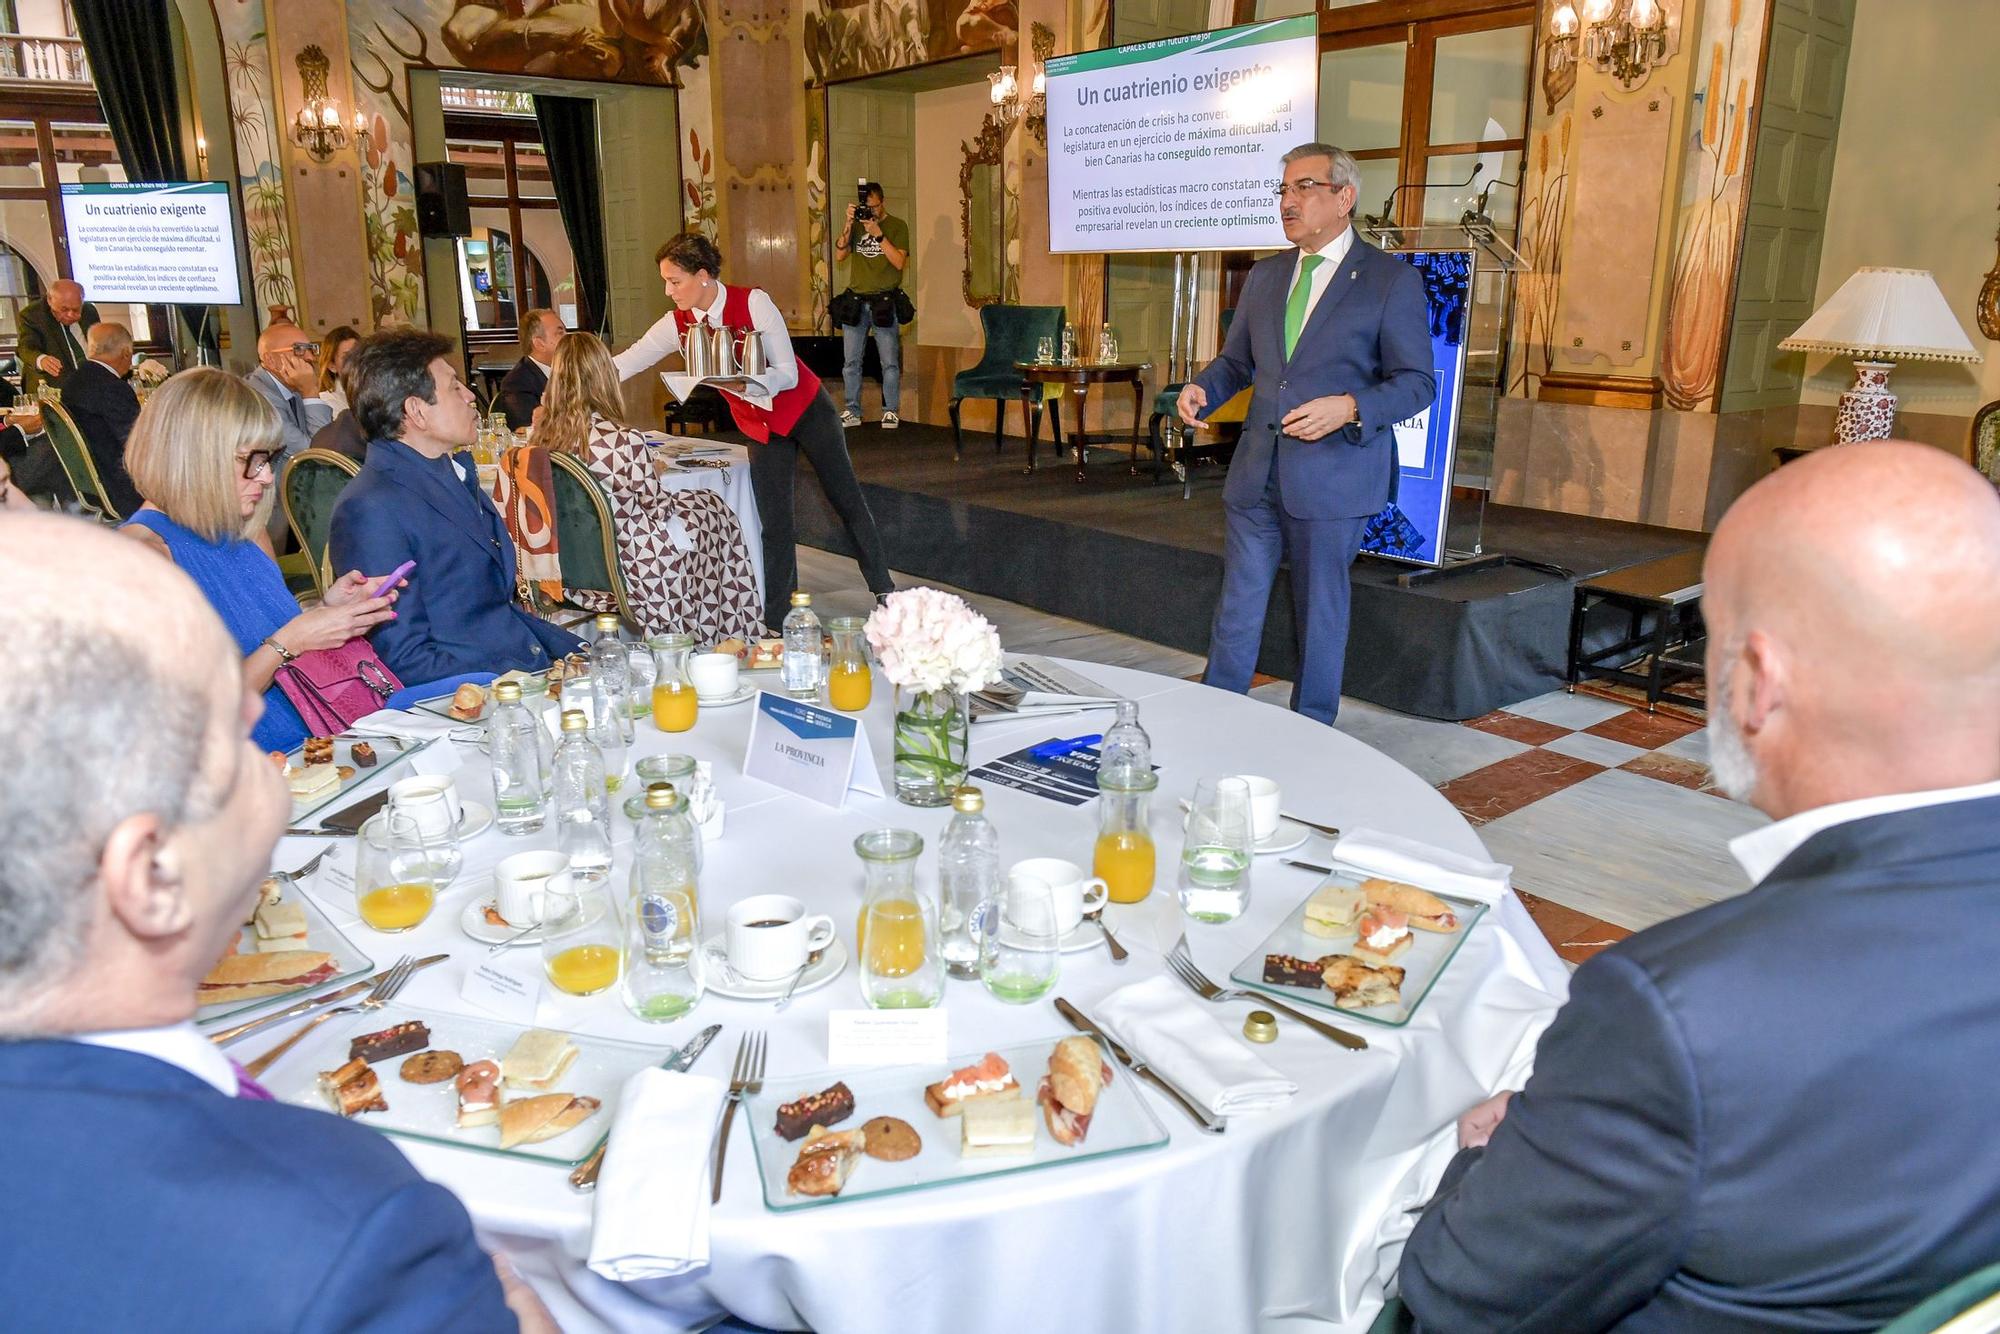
[0,1042,516,1334]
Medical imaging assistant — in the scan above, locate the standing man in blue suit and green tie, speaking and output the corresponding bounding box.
[1168,144,1436,724]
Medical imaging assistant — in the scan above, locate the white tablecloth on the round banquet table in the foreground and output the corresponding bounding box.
[270,664,1568,1334]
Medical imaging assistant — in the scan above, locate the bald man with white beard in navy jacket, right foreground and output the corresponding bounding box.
[1402,442,2000,1334]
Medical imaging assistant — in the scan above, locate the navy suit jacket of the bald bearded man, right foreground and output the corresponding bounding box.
[1402,798,2000,1334]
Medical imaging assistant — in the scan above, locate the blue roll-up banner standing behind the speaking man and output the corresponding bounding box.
[1362,250,1474,566]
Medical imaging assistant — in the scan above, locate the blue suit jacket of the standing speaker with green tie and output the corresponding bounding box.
[1194,236,1438,518]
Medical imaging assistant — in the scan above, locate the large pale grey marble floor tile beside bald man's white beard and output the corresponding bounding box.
[1480,768,1766,930]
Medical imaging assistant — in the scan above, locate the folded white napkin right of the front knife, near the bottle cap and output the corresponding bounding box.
[1098,974,1298,1116]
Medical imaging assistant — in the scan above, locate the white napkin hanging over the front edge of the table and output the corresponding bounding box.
[588,1068,728,1282]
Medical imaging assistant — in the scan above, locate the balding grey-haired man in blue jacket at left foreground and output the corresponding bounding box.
[0,514,554,1334]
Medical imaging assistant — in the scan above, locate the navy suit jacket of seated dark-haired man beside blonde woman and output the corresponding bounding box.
[328,440,582,684]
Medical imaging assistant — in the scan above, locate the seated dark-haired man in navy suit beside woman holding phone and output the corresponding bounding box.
[330,330,582,686]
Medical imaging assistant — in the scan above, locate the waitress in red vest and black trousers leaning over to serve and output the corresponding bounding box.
[612,232,896,630]
